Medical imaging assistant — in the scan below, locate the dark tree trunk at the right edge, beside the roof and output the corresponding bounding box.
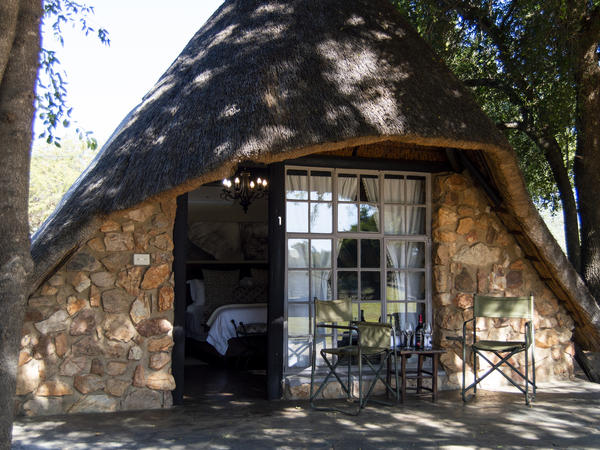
[574,7,600,303]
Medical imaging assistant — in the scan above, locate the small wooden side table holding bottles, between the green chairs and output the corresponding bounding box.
[388,348,446,402]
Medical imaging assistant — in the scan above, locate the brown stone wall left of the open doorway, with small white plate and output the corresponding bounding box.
[16,199,176,415]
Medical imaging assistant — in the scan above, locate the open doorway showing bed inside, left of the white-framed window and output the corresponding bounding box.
[176,178,269,403]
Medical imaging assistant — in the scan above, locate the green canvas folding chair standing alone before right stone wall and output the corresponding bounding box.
[448,295,536,405]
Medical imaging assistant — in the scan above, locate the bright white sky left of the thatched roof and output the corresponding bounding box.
[37,0,223,146]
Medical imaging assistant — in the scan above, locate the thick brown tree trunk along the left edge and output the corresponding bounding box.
[0,0,42,449]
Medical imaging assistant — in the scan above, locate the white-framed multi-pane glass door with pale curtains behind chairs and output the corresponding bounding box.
[284,166,431,372]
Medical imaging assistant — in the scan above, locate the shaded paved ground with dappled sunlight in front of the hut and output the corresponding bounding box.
[13,381,600,449]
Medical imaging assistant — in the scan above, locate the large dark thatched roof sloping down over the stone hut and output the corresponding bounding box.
[32,0,600,348]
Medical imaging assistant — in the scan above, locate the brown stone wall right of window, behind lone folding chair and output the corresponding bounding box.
[432,174,574,387]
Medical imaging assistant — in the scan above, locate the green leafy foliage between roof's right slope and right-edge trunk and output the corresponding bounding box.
[395,0,584,211]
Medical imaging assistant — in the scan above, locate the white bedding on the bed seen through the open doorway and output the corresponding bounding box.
[206,303,267,355]
